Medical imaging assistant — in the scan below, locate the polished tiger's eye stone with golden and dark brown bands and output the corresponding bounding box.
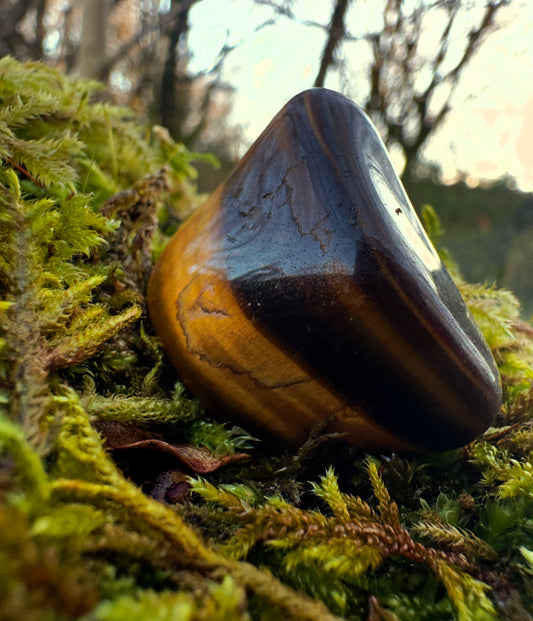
[148,89,501,451]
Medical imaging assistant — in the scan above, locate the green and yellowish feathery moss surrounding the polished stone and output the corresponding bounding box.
[0,58,533,621]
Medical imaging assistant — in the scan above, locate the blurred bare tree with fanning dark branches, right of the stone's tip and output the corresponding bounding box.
[365,0,509,177]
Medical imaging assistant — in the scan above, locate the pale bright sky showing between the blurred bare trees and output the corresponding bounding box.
[189,0,533,192]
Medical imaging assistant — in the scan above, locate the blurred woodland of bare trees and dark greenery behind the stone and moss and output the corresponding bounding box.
[0,0,533,310]
